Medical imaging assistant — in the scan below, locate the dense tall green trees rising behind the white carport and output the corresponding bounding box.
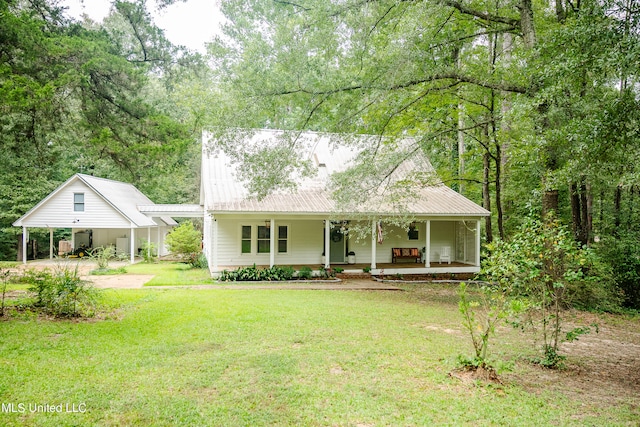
[0,0,199,259]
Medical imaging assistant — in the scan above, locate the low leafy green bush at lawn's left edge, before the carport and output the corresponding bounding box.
[25,265,99,317]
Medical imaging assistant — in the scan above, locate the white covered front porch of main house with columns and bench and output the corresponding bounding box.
[205,214,481,276]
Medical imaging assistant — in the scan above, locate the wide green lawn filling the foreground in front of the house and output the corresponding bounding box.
[0,289,638,426]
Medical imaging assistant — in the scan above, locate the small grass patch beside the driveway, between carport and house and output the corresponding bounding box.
[127,262,213,286]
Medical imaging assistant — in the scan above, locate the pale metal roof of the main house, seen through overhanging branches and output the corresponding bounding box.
[202,130,490,216]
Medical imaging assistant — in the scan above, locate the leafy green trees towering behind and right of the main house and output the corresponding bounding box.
[211,0,639,247]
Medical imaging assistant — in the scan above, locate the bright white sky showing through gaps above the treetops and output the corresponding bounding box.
[60,0,221,53]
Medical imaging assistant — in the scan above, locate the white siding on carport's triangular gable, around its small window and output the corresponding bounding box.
[23,180,131,229]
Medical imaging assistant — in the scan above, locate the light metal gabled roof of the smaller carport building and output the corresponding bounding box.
[13,173,177,227]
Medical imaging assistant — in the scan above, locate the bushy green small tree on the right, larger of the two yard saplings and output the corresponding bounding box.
[482,217,615,366]
